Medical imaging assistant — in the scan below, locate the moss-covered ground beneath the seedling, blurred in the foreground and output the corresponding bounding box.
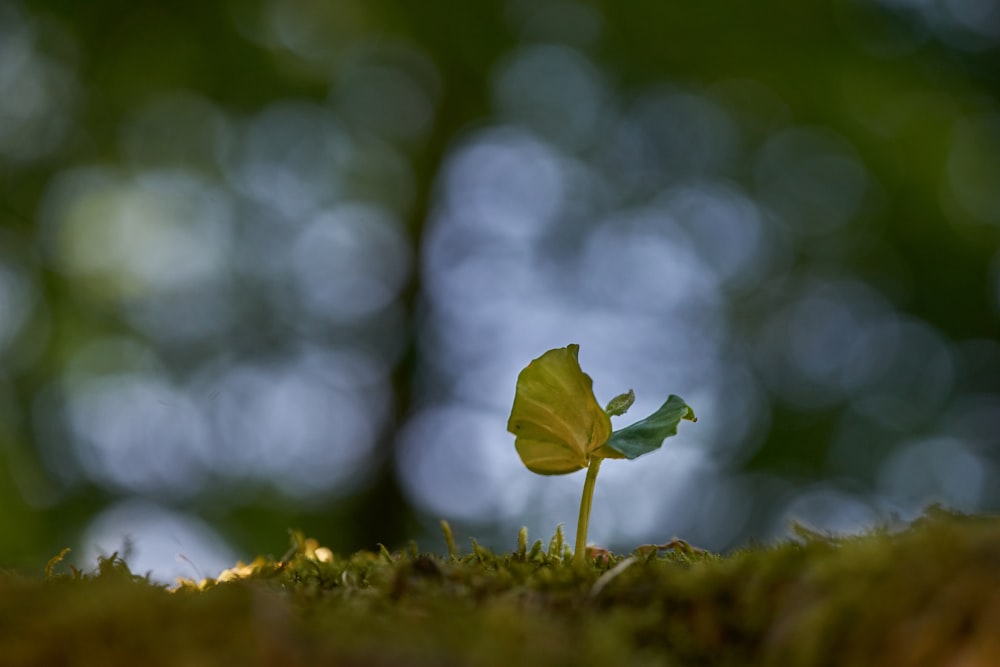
[0,511,1000,667]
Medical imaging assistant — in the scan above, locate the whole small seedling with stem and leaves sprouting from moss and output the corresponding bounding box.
[507,344,697,562]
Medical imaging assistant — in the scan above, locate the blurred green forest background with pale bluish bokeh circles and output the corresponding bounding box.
[0,0,1000,581]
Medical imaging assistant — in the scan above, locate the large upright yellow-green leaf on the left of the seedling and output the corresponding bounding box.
[507,344,611,475]
